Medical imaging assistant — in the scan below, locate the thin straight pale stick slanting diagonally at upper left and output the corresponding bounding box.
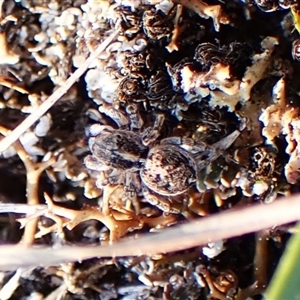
[0,31,118,152]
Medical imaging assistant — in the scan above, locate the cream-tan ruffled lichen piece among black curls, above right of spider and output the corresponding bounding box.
[180,37,278,111]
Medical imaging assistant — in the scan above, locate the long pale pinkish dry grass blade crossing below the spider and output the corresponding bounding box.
[0,195,300,270]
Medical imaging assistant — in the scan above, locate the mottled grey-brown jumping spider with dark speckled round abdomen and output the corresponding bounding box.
[84,105,240,213]
